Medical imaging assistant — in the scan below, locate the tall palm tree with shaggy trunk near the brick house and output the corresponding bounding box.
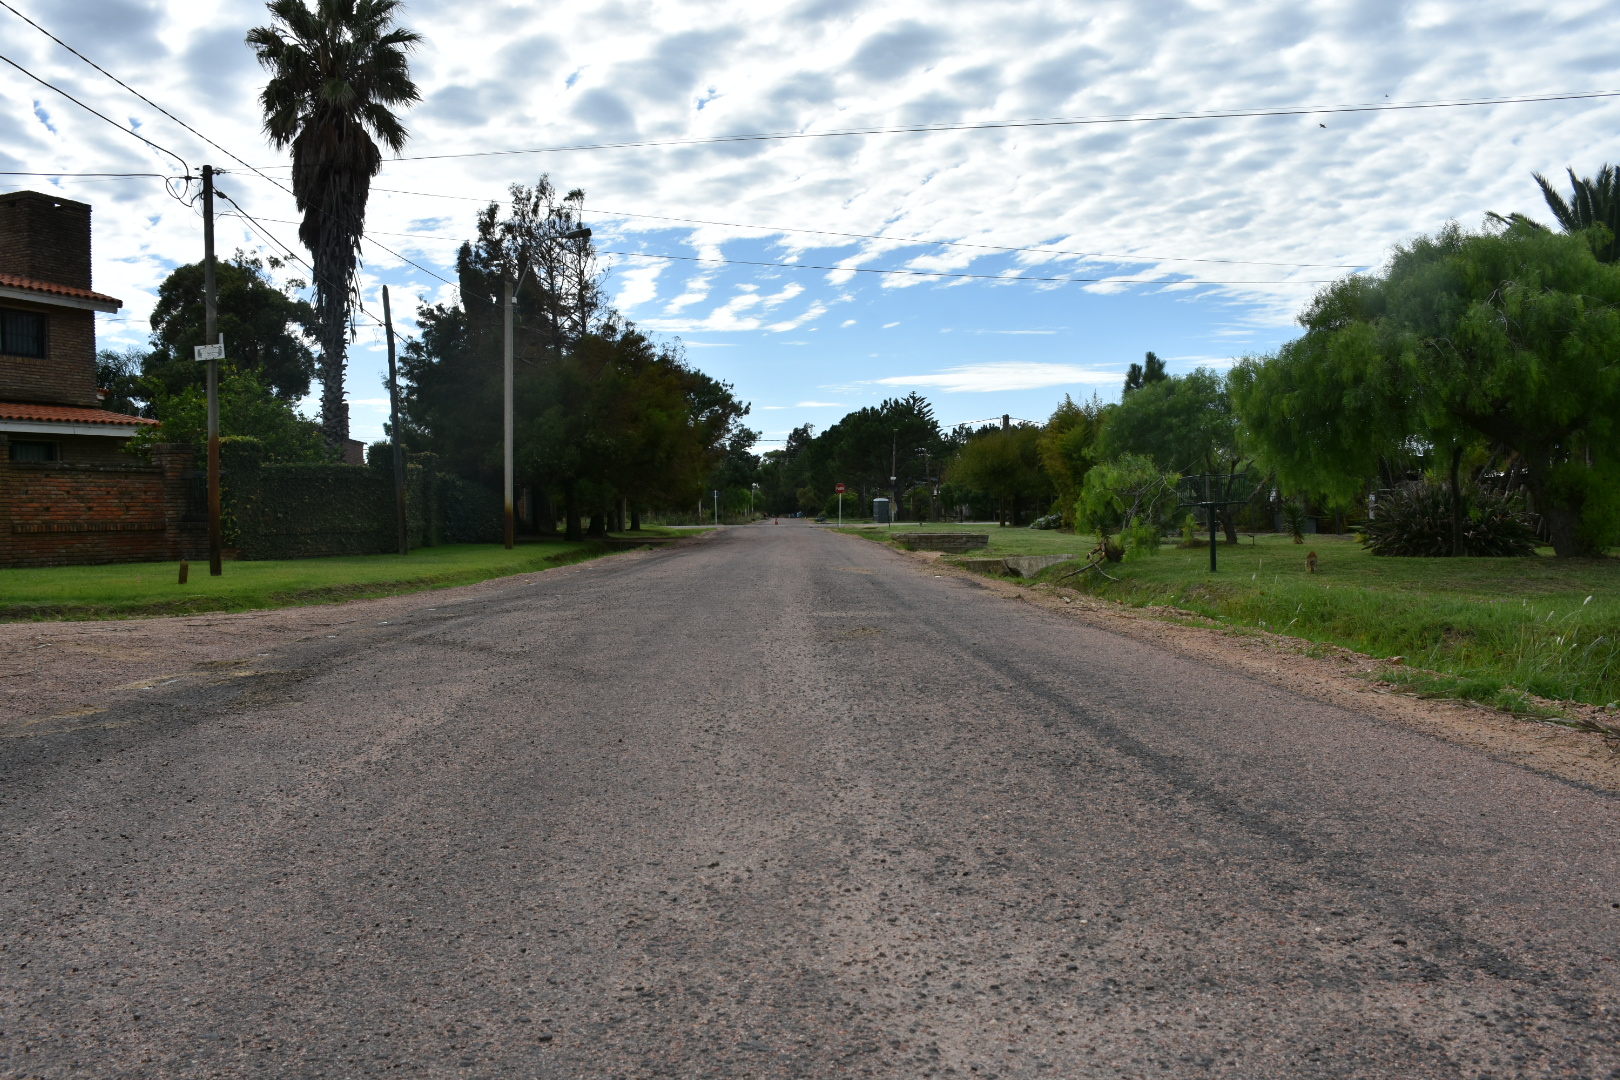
[248,0,421,449]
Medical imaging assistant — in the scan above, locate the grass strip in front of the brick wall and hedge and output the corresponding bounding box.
[0,529,667,620]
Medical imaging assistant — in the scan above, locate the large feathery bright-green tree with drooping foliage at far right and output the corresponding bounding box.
[1233,222,1620,555]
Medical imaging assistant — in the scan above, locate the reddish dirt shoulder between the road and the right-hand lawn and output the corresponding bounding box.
[897,551,1620,792]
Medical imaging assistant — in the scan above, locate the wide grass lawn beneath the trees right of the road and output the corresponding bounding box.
[855,525,1620,711]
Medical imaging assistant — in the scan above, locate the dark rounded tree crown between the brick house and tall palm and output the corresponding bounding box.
[143,251,316,402]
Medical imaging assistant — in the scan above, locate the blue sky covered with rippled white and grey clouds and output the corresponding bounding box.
[0,0,1620,450]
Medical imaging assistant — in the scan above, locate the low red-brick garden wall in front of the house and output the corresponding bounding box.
[0,436,206,567]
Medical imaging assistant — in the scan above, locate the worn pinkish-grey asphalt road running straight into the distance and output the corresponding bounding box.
[0,523,1620,1078]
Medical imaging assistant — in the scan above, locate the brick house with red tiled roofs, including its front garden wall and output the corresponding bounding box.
[0,191,194,567]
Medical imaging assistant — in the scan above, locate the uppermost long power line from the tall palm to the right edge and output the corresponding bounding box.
[249,91,1620,168]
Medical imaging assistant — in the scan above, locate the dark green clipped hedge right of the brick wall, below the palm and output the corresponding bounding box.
[220,439,502,559]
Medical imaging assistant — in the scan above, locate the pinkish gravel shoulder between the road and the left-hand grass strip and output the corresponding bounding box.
[0,538,664,738]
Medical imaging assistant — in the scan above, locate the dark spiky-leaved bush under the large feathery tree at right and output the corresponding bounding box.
[1361,481,1536,557]
